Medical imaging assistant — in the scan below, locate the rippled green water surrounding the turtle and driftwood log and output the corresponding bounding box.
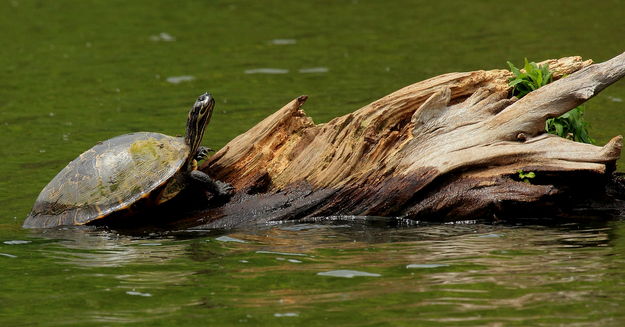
[0,0,625,326]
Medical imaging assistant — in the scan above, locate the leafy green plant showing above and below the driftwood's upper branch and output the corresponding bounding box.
[508,58,595,144]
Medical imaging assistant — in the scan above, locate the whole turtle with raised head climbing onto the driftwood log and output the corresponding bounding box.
[23,93,234,228]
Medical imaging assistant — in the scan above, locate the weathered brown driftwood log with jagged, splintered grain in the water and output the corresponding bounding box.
[106,53,625,228]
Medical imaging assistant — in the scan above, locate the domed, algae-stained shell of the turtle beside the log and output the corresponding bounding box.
[24,132,190,228]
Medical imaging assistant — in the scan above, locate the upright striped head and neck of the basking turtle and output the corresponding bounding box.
[184,93,215,156]
